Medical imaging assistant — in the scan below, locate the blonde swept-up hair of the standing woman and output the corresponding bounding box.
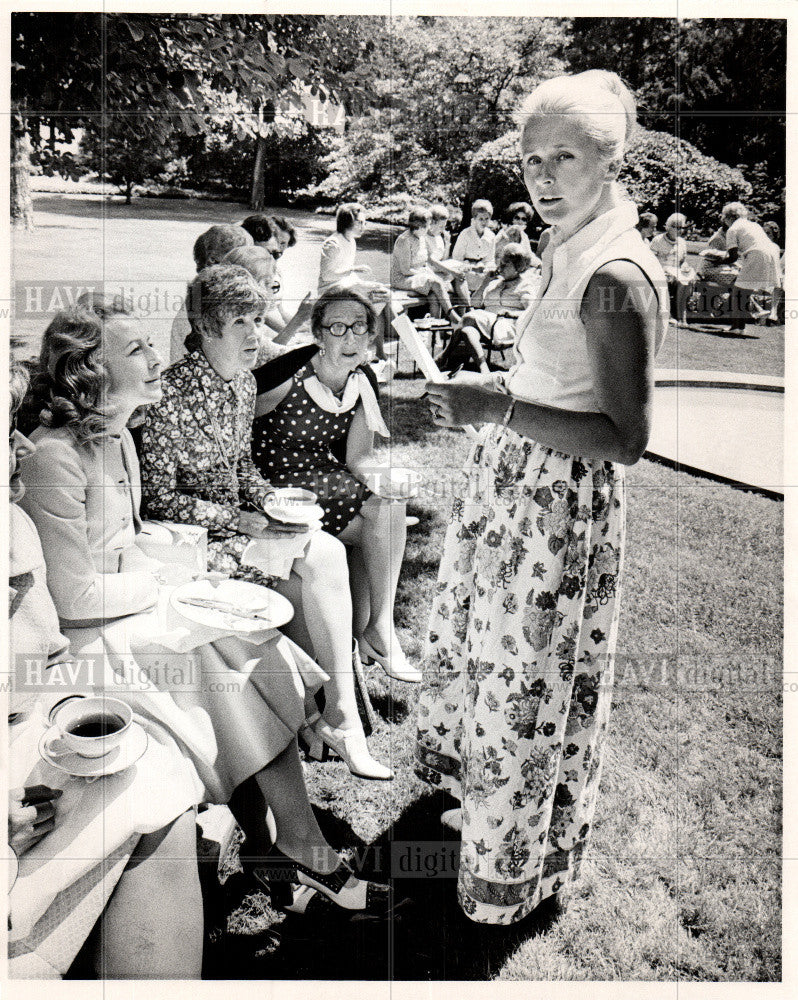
[515,69,637,170]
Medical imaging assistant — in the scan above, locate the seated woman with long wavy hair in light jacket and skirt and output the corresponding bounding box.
[22,302,394,909]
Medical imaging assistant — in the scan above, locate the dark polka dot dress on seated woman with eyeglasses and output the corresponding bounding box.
[252,365,371,535]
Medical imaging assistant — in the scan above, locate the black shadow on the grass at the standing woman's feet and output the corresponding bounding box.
[203,792,558,981]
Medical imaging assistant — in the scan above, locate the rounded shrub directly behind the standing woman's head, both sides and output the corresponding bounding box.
[467,128,752,232]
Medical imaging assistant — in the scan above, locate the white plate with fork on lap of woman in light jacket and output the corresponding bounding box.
[169,580,294,632]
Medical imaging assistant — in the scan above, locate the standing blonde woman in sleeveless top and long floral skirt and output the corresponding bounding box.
[417,71,668,924]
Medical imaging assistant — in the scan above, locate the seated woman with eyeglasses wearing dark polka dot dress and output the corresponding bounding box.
[252,286,421,683]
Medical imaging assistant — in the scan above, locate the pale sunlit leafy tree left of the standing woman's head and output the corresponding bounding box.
[313,16,561,213]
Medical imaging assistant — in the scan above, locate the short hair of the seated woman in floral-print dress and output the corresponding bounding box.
[185,264,269,351]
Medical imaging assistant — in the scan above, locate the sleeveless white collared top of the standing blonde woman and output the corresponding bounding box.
[504,201,669,412]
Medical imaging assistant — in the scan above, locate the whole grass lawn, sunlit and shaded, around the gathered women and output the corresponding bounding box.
[13,196,783,981]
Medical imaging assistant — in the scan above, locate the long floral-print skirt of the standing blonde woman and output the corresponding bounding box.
[416,425,625,924]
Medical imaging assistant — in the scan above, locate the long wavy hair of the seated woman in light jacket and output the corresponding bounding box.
[26,295,133,444]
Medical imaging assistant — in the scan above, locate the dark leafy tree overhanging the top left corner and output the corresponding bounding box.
[12,13,378,224]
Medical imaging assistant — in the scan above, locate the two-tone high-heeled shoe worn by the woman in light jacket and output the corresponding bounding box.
[253,845,392,916]
